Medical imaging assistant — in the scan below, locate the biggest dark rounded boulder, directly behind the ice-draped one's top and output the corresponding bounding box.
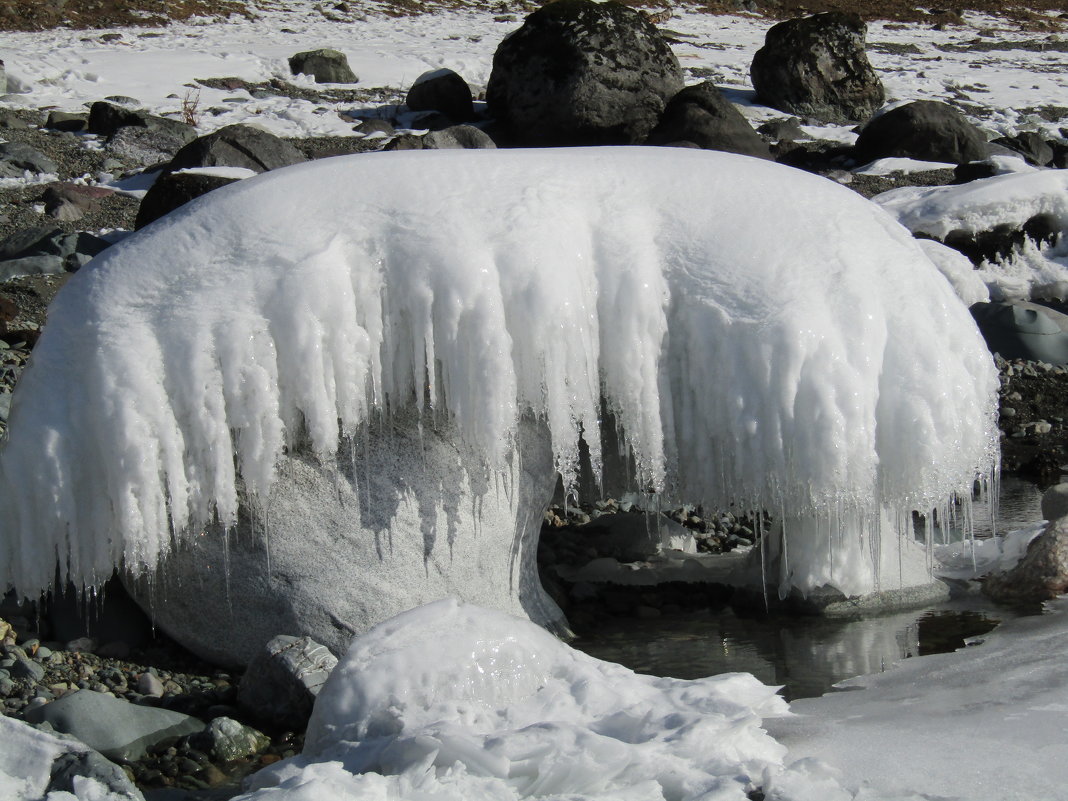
[486,0,682,146]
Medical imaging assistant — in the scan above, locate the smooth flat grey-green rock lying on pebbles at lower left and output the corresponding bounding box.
[26,690,204,761]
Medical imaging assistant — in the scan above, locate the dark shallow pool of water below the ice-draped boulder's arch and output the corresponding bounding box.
[571,597,1012,700]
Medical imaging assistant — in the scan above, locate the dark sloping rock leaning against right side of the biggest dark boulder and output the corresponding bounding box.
[646,81,771,158]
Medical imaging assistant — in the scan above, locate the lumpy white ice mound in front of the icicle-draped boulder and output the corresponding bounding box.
[244,599,788,801]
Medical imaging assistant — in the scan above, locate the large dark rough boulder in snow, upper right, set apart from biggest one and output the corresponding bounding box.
[750,12,886,122]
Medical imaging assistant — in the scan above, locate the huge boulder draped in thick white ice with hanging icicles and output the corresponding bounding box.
[0,147,996,661]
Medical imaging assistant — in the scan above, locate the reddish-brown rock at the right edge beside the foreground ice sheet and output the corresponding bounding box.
[983,517,1068,603]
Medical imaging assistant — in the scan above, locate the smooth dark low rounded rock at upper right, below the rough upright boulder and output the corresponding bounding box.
[854,100,987,164]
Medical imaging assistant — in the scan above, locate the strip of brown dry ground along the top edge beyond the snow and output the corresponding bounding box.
[0,0,1068,30]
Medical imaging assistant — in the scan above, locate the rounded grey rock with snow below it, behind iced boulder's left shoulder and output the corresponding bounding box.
[166,125,308,173]
